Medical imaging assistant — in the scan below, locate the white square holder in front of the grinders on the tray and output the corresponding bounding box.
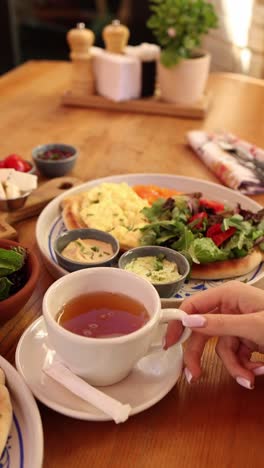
[93,51,141,102]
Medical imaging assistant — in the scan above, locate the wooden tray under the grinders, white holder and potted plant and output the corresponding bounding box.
[62,91,210,119]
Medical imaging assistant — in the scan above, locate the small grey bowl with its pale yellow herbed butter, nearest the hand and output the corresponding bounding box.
[118,245,190,298]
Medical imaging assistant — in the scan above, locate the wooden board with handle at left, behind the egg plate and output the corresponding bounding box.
[0,177,83,239]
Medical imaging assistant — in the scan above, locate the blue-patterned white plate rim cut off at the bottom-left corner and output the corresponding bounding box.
[0,356,43,468]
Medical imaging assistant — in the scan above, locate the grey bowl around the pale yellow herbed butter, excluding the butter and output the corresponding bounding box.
[118,245,190,298]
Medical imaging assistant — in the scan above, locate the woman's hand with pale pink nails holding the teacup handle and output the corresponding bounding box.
[165,281,264,389]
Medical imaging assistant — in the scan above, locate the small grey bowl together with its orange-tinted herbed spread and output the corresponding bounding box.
[53,228,119,272]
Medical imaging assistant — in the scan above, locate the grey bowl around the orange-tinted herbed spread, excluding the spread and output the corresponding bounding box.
[53,228,119,272]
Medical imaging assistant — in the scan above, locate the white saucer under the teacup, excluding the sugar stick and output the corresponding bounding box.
[16,317,182,421]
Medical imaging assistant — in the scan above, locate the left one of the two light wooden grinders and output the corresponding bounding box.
[67,23,95,95]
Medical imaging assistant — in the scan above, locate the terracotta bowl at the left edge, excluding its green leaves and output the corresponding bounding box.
[0,239,39,324]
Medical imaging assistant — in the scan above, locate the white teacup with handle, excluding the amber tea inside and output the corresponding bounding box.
[43,267,191,386]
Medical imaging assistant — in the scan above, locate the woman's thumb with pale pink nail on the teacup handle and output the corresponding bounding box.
[182,312,264,345]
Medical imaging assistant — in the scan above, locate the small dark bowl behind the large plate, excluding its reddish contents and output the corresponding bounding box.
[32,143,78,178]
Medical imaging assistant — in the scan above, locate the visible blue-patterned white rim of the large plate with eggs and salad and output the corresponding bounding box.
[36,174,264,302]
